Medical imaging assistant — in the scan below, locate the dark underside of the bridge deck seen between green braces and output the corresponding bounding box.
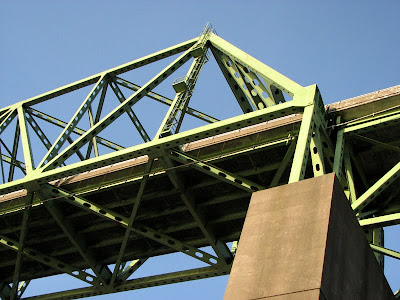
[0,85,400,282]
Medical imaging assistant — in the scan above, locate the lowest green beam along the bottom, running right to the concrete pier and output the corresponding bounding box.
[24,265,231,300]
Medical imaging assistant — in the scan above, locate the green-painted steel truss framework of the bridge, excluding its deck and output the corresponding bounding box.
[0,25,400,299]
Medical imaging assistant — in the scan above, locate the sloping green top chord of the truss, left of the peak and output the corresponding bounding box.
[0,37,199,110]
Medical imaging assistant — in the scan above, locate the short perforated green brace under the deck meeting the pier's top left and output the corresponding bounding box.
[168,150,265,193]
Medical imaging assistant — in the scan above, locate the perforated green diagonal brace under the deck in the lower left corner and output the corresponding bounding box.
[0,234,100,285]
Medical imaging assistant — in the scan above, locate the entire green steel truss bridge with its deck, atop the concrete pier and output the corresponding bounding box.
[0,25,400,299]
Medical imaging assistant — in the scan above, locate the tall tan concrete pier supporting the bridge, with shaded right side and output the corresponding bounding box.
[224,174,394,300]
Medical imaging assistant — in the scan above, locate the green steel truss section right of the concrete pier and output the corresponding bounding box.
[334,101,400,274]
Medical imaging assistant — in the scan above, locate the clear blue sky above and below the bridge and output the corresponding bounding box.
[0,0,400,300]
